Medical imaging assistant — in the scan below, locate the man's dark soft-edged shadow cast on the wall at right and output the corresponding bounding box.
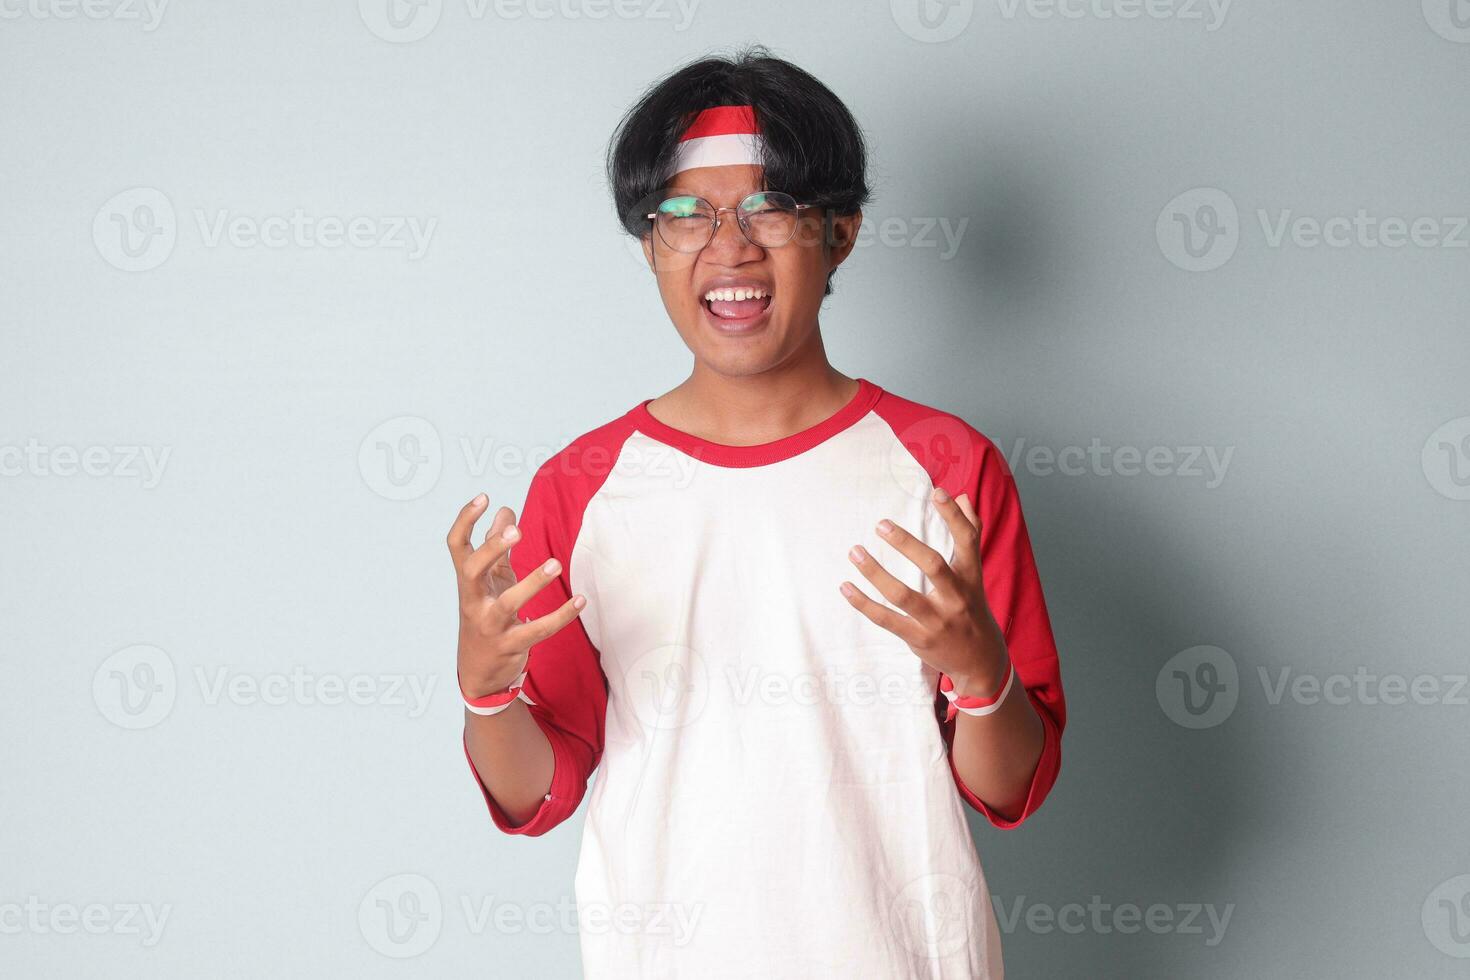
[947,147,1294,980]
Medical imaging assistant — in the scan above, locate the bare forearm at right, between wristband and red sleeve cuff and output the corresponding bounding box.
[951,664,1045,820]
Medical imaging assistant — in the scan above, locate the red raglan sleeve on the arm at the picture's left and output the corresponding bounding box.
[465,453,607,836]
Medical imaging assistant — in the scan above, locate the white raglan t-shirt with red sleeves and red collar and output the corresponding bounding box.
[466,379,1066,980]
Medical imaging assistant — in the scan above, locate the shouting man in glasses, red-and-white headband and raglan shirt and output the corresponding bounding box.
[448,50,1066,980]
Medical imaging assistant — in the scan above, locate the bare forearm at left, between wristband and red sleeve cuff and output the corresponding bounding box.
[465,699,554,823]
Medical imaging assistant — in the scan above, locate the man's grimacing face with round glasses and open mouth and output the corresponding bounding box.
[644,165,861,376]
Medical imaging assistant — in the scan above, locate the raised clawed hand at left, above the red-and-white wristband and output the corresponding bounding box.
[448,494,587,698]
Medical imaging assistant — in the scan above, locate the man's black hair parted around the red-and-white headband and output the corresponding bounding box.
[607,44,872,295]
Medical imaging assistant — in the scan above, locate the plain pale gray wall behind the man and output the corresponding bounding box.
[0,0,1470,979]
